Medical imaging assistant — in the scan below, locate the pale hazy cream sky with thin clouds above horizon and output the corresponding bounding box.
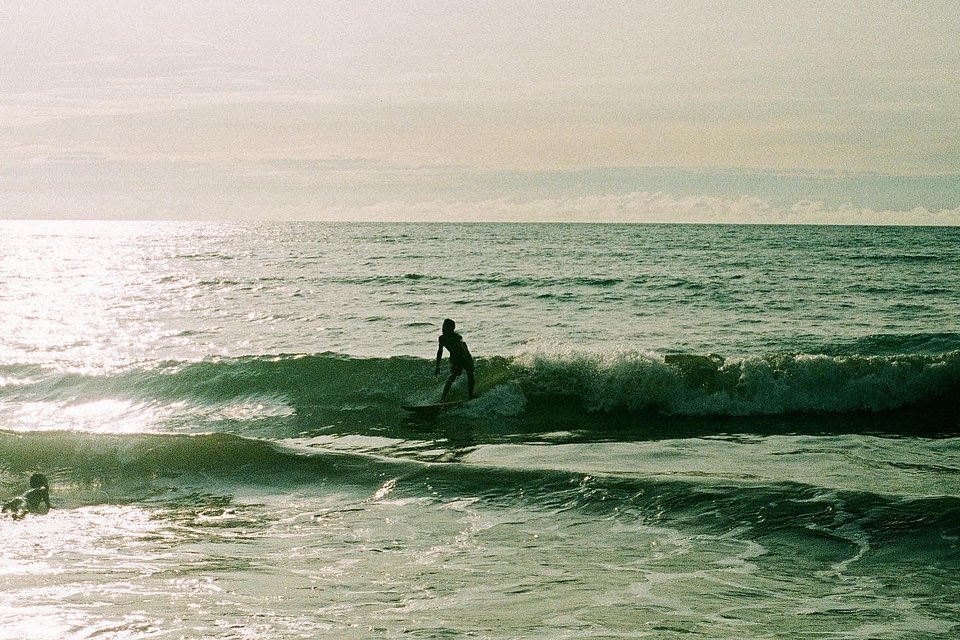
[0,0,960,225]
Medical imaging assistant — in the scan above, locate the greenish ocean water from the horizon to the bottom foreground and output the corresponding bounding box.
[0,221,960,640]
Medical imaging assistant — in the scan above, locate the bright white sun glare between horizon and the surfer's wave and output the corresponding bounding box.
[0,222,175,372]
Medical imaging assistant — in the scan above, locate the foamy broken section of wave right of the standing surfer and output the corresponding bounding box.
[521,351,960,416]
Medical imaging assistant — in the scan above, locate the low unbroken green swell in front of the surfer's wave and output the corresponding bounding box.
[0,431,960,556]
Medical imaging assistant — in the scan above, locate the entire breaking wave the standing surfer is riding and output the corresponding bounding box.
[0,351,960,437]
